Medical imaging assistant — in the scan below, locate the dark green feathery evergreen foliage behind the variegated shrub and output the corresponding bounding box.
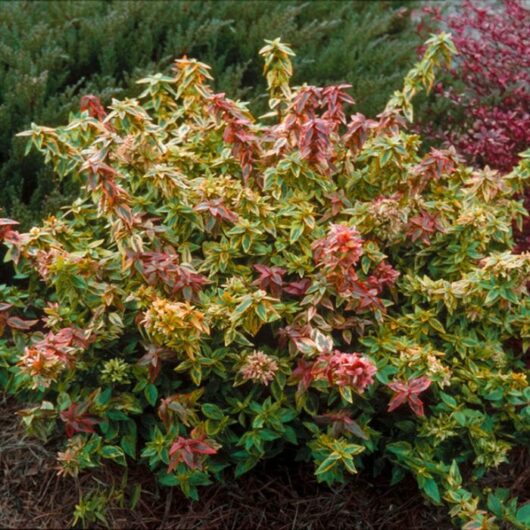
[0,1,417,225]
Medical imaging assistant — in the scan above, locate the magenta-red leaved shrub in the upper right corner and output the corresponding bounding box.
[414,0,530,252]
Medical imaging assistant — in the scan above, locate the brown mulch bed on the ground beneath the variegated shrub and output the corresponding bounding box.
[0,394,530,530]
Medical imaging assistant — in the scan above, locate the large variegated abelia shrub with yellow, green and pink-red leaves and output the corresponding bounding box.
[0,34,530,528]
